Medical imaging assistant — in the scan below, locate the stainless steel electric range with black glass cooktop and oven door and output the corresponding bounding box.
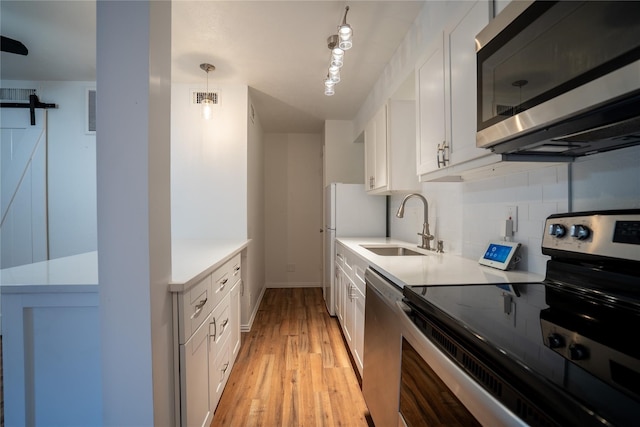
[399,210,640,426]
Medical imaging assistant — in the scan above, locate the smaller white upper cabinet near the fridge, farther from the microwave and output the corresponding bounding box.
[364,99,419,194]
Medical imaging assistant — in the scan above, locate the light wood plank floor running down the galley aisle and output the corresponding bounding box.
[211,288,372,427]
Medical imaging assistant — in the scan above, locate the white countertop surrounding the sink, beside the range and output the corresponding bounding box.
[337,237,544,287]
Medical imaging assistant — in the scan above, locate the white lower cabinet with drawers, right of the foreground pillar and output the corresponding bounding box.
[173,254,242,427]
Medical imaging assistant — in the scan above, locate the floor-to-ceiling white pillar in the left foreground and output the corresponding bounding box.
[97,2,174,426]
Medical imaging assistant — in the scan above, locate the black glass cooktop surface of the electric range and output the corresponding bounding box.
[404,283,640,425]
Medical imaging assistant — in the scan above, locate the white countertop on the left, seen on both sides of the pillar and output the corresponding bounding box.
[0,239,250,293]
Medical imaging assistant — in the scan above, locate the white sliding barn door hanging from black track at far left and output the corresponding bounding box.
[0,108,48,268]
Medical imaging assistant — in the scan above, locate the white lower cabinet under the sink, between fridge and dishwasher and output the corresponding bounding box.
[336,242,369,375]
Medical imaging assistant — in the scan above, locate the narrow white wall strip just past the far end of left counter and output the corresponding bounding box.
[241,93,265,330]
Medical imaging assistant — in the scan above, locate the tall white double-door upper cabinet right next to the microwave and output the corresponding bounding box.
[416,0,499,181]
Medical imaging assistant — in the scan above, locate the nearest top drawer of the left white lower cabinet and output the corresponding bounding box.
[178,275,214,343]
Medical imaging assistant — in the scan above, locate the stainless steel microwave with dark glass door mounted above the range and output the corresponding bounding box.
[476,1,640,158]
